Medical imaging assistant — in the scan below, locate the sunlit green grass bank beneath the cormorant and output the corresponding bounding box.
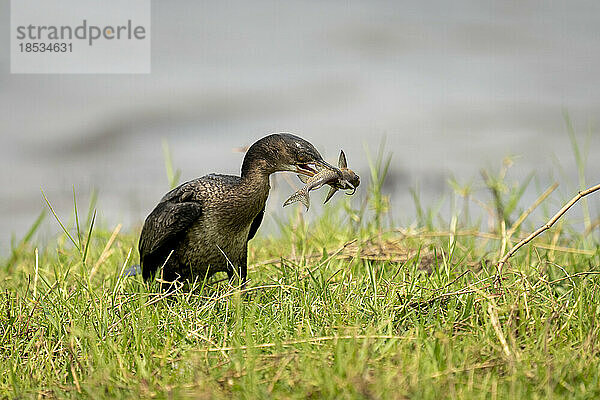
[0,149,600,399]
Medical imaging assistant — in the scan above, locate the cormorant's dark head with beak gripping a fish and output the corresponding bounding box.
[242,133,342,177]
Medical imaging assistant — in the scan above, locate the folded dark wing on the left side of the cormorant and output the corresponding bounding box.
[139,188,202,279]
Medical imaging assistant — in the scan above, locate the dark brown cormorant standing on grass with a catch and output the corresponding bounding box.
[139,133,341,283]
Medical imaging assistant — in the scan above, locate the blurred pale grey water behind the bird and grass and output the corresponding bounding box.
[0,0,600,255]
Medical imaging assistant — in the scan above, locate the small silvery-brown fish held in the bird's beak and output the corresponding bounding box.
[283,150,360,210]
